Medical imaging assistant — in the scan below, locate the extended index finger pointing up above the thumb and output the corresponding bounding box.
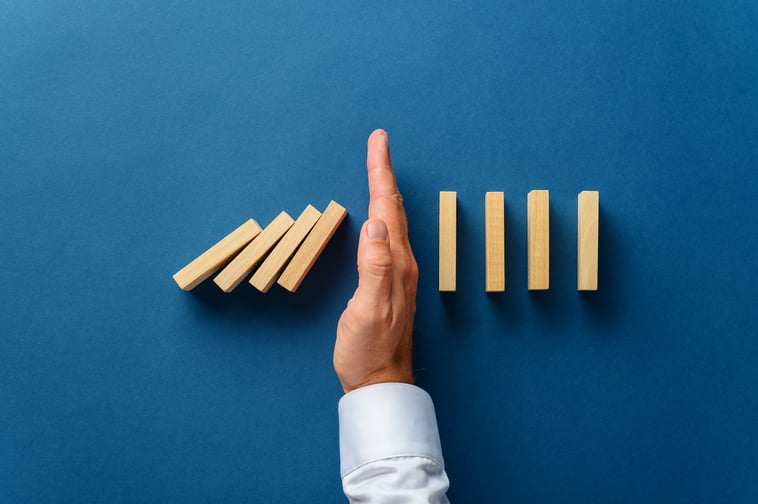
[366,129,408,245]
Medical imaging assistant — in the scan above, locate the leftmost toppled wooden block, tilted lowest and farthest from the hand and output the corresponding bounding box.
[174,219,261,290]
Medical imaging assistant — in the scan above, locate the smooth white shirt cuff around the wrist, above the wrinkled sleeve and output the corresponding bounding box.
[339,383,445,478]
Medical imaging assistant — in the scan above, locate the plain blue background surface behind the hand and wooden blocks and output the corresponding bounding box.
[0,0,758,503]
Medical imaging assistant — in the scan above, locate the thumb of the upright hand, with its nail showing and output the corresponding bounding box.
[357,219,392,305]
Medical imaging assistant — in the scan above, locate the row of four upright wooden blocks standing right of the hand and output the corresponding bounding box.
[439,190,600,292]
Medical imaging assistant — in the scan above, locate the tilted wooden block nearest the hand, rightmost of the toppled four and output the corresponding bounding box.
[277,201,347,292]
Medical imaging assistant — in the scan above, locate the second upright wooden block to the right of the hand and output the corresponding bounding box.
[484,192,505,292]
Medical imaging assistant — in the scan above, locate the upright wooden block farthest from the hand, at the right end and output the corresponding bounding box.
[576,191,600,290]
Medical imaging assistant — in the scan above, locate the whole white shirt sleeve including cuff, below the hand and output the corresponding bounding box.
[339,383,449,504]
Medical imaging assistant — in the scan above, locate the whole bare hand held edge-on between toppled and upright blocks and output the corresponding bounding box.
[334,130,418,393]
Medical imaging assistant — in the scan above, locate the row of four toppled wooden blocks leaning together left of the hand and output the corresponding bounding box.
[174,201,347,292]
